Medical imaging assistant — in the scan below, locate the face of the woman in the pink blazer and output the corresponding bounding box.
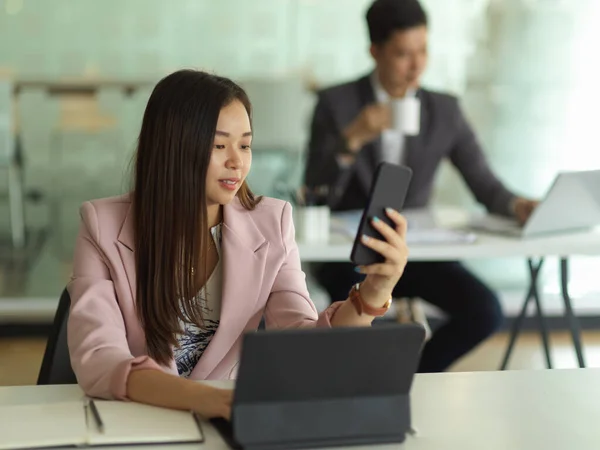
[206,100,252,206]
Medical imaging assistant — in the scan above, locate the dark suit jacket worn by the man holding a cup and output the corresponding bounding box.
[305,76,514,215]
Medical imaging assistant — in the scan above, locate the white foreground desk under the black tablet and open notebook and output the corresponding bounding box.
[0,369,600,450]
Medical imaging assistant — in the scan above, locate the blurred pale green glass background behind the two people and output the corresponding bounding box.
[0,0,600,320]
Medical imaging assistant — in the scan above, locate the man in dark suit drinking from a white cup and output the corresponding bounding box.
[305,0,536,372]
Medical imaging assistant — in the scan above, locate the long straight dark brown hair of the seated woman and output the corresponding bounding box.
[132,70,260,364]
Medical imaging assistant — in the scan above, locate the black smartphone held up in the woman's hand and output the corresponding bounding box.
[350,162,412,266]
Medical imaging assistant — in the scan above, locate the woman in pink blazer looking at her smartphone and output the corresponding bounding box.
[68,71,407,417]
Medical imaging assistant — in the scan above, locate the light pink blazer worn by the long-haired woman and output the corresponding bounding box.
[67,195,339,399]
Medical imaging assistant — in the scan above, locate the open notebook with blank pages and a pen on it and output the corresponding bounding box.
[0,399,204,449]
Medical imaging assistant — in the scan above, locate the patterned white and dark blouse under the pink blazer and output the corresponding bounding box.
[174,224,223,378]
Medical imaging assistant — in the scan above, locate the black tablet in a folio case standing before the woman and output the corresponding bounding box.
[211,324,425,449]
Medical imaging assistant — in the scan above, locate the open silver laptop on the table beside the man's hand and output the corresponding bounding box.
[471,170,600,238]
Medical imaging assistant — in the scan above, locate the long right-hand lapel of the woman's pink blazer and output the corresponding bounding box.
[191,200,269,379]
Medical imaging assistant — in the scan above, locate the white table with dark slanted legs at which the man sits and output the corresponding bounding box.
[298,208,600,369]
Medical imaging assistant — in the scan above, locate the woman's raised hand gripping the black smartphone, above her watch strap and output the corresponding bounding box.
[358,208,408,308]
